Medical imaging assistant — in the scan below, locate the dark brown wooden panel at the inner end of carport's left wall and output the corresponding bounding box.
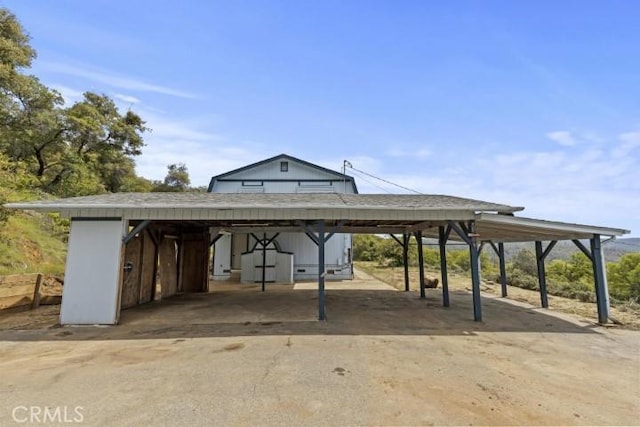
[180,232,209,292]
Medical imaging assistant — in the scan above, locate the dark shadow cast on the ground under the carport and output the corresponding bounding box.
[0,285,596,341]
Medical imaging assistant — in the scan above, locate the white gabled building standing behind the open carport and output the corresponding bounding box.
[208,154,358,283]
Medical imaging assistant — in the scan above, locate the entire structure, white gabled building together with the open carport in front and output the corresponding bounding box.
[6,155,629,325]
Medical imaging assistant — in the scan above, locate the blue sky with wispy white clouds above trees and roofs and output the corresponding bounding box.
[5,0,640,236]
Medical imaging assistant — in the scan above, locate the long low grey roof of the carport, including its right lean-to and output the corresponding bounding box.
[6,192,629,242]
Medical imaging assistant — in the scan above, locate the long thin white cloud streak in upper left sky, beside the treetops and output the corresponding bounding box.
[39,62,196,99]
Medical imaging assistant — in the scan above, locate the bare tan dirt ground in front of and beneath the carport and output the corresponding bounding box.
[0,273,640,426]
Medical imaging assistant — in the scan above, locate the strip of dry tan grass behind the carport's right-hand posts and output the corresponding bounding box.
[356,262,640,330]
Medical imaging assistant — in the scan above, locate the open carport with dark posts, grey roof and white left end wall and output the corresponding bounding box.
[7,193,628,324]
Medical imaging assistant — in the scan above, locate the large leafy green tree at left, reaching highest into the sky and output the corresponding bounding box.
[0,8,148,196]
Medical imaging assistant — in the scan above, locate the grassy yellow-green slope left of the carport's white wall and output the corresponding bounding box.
[0,212,67,275]
